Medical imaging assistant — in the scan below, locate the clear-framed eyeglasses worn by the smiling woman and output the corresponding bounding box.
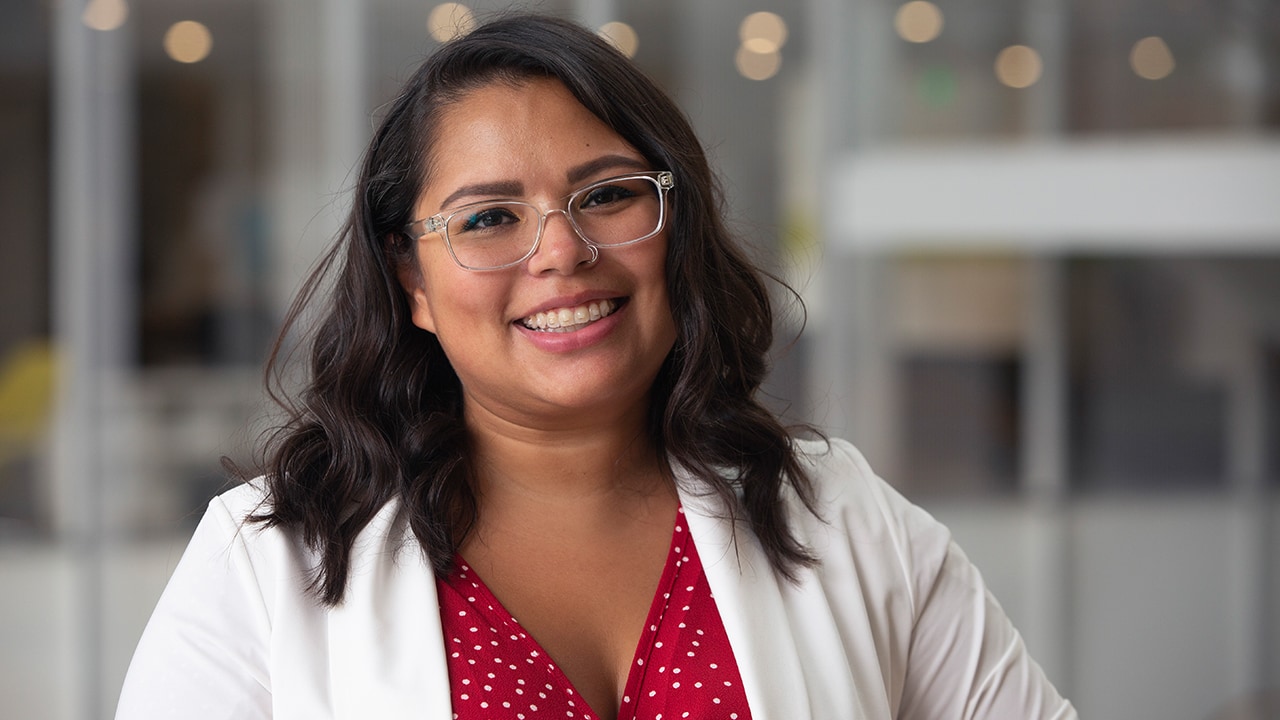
[404,170,676,270]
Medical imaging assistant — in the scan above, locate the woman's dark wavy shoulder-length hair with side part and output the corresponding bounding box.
[240,15,815,605]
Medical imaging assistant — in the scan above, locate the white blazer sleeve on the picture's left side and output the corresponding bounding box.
[115,497,271,720]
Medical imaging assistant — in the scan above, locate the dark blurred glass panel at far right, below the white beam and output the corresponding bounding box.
[1068,256,1280,489]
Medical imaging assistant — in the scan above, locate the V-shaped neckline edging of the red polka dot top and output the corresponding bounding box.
[451,506,692,720]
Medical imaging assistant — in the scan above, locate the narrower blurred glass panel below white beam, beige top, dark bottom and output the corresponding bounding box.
[891,255,1028,496]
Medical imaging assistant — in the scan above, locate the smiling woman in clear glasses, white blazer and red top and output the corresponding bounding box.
[118,17,1074,720]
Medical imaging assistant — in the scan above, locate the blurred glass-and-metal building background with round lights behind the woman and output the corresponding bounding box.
[0,0,1280,720]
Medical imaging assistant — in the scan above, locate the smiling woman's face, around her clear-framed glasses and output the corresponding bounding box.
[401,78,678,428]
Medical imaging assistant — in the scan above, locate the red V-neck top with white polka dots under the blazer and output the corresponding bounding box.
[436,509,751,720]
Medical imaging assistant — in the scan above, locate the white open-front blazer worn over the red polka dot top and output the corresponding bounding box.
[116,441,1076,720]
